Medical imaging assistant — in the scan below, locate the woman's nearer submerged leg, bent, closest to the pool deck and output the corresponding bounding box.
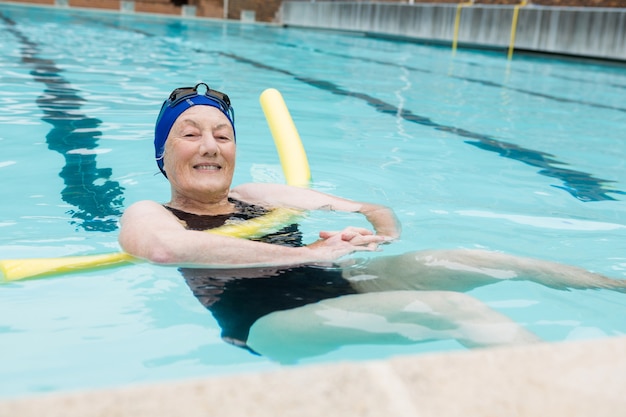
[248,291,539,363]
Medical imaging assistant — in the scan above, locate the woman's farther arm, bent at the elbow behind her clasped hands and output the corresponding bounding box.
[231,184,401,239]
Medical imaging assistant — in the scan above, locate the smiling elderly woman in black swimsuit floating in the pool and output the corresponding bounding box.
[119,83,624,356]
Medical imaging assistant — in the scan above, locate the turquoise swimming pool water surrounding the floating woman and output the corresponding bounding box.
[0,0,626,396]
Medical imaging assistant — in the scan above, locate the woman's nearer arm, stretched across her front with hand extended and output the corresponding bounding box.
[114,201,384,267]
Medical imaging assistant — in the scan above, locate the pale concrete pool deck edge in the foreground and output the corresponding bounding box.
[0,337,626,417]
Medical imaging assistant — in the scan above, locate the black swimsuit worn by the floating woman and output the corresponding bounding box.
[167,199,356,347]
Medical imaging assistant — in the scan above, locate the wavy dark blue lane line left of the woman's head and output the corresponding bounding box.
[0,13,124,232]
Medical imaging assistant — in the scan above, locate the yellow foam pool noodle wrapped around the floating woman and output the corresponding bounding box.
[0,88,311,282]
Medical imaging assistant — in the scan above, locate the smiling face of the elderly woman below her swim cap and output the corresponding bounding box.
[163,105,236,212]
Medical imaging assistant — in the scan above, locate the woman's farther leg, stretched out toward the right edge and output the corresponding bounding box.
[344,249,626,292]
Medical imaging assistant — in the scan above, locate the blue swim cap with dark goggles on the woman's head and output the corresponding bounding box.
[154,83,235,178]
